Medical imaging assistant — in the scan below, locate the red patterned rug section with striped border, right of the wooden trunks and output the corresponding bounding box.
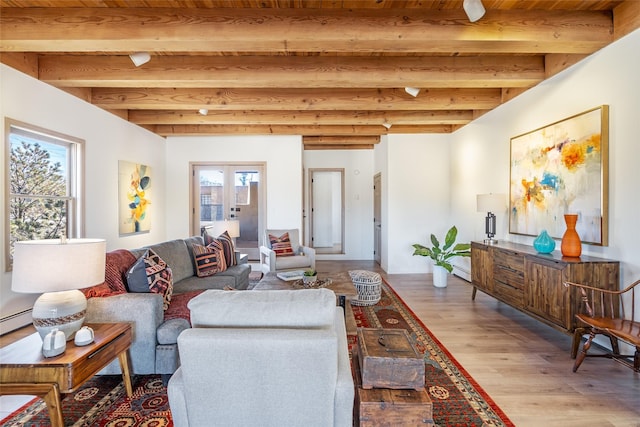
[349,282,514,427]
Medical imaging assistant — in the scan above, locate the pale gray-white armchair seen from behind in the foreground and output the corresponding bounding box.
[168,289,354,427]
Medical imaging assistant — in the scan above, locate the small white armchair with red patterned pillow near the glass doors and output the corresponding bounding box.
[260,228,316,273]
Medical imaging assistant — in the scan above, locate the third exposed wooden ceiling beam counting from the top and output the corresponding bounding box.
[91,88,502,111]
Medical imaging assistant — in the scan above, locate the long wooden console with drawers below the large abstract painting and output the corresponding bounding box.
[471,242,620,333]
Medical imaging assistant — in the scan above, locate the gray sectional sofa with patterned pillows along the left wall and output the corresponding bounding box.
[86,236,251,374]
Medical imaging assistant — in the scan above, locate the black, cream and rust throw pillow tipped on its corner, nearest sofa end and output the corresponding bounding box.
[127,249,173,310]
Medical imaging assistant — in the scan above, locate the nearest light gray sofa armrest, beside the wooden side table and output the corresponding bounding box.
[85,293,164,374]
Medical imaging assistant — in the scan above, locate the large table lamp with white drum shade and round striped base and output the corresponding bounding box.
[11,238,106,340]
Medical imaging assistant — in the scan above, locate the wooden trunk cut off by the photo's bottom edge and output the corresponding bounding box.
[353,352,435,427]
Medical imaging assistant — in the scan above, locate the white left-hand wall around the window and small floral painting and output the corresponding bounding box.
[0,64,166,333]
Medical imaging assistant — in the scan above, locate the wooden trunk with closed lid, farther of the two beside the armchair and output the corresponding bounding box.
[358,328,424,390]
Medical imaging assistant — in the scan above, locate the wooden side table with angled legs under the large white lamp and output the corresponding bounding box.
[0,323,133,427]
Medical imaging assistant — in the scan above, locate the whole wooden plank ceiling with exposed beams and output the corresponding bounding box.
[0,0,640,149]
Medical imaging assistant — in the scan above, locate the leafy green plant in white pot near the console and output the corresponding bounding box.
[413,225,471,287]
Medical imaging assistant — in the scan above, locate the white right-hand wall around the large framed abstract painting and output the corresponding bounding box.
[451,30,640,285]
